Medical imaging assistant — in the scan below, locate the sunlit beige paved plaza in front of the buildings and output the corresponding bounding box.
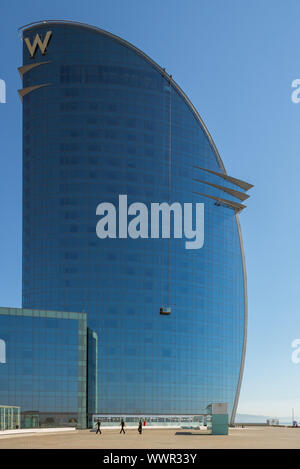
[0,427,300,449]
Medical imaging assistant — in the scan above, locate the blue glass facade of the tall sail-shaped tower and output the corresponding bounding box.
[21,22,246,424]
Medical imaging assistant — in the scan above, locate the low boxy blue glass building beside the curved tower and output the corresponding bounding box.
[0,308,88,428]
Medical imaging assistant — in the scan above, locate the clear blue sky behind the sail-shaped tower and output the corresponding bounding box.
[0,0,300,417]
